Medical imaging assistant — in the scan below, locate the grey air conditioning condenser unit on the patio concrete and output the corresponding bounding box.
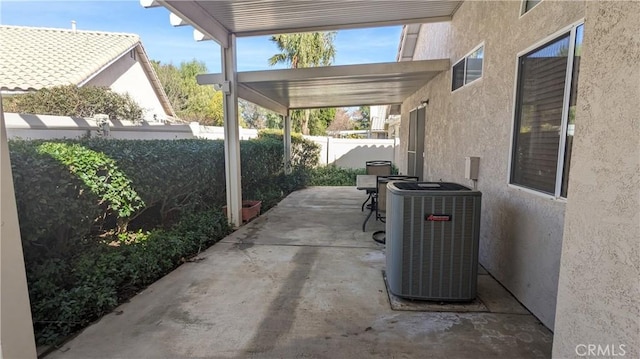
[386,182,482,301]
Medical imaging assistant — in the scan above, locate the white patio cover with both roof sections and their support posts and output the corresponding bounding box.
[140,0,462,225]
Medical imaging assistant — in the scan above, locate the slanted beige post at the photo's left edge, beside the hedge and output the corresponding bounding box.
[0,96,37,359]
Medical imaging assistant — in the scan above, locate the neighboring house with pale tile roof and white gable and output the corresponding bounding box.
[0,25,176,122]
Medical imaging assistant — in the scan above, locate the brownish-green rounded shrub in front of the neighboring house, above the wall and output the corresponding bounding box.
[3,85,143,122]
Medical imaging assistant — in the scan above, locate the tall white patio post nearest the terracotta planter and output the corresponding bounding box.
[221,34,242,227]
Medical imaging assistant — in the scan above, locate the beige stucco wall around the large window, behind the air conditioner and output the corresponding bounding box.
[398,0,584,329]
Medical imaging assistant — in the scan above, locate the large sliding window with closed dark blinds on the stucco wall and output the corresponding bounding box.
[510,24,584,198]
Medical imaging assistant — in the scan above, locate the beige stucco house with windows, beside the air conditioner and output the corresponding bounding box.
[396,1,640,357]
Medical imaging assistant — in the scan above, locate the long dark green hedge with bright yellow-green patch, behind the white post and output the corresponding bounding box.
[10,137,317,249]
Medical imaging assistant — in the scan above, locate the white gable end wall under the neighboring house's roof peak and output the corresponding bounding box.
[85,47,167,121]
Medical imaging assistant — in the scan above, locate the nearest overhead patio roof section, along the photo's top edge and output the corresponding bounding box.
[151,0,462,47]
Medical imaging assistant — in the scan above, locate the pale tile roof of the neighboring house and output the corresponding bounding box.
[0,25,140,91]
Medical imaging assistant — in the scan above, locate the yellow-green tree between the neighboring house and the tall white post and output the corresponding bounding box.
[152,60,224,126]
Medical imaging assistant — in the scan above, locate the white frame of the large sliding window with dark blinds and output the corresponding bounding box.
[510,19,585,203]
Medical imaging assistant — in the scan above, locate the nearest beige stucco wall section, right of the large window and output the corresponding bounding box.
[553,1,640,358]
